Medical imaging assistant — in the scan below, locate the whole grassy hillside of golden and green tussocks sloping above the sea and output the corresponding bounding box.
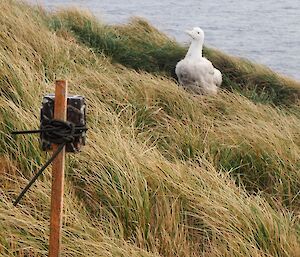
[0,0,300,257]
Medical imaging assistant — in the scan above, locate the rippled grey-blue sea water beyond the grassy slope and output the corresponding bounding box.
[29,0,300,80]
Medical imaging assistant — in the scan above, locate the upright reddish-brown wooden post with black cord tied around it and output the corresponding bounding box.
[49,80,68,257]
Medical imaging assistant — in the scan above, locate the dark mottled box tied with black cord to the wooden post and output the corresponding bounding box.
[40,94,86,153]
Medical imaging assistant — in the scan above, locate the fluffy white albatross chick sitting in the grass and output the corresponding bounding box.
[175,27,222,94]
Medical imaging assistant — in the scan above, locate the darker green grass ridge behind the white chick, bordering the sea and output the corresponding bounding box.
[47,9,300,105]
